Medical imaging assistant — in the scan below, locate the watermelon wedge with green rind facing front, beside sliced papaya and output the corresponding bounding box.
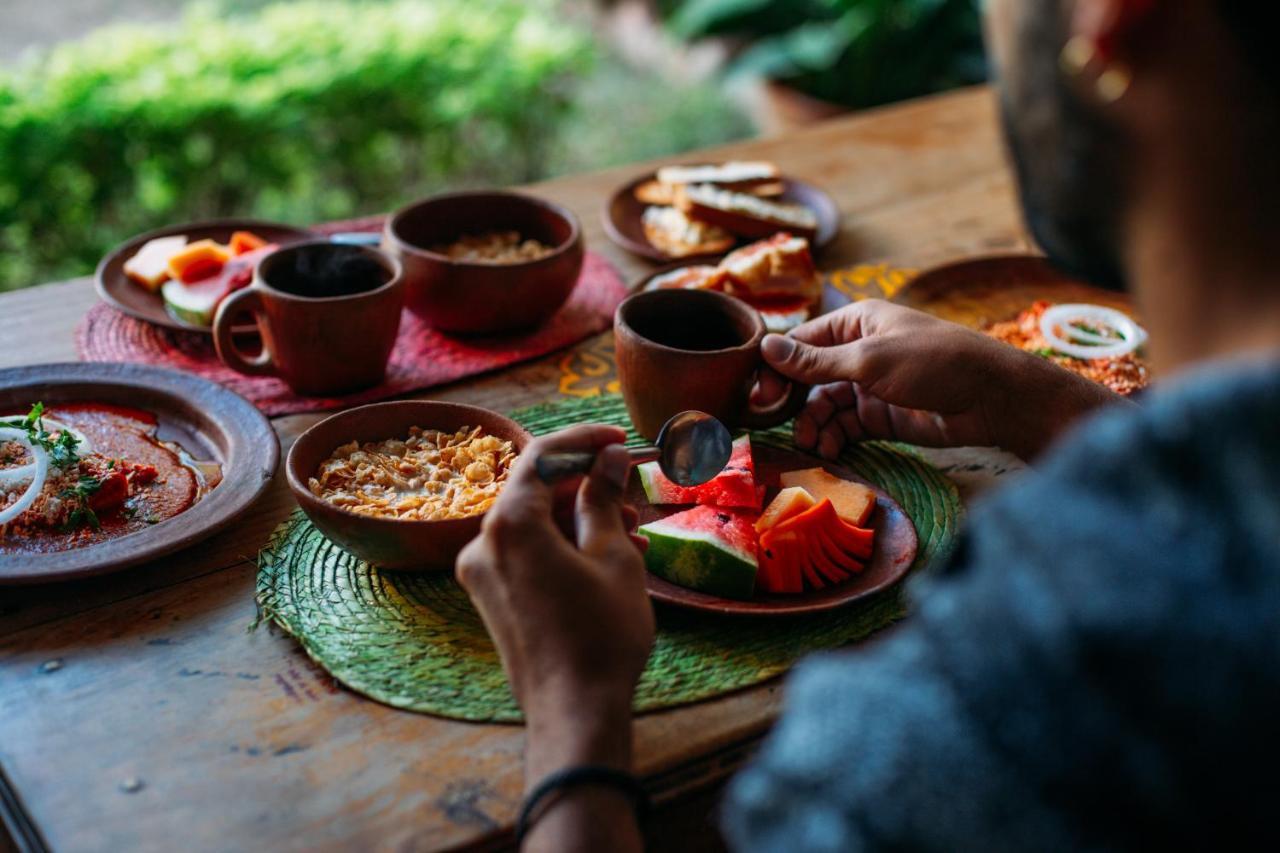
[639,506,758,598]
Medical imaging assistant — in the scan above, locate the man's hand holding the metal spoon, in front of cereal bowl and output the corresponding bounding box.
[458,427,654,779]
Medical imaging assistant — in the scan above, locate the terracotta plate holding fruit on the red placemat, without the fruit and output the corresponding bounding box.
[93,219,316,334]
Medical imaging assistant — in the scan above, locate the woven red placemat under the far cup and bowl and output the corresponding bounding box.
[76,218,627,415]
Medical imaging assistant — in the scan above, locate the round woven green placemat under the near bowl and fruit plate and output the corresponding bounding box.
[257,396,960,722]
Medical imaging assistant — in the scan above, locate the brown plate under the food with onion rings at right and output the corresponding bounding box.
[893,255,1135,329]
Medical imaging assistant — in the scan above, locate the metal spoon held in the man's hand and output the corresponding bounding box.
[534,411,733,485]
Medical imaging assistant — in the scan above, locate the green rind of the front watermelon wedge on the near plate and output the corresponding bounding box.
[639,510,759,599]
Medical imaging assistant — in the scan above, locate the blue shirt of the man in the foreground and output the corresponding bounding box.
[724,361,1280,853]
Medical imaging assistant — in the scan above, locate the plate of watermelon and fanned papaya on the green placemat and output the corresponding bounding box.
[628,435,918,616]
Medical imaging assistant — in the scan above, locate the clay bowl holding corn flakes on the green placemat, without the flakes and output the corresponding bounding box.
[284,401,531,570]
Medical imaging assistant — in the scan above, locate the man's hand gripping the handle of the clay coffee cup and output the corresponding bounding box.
[755,300,1121,459]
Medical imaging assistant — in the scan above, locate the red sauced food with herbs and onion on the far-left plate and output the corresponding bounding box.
[0,403,221,555]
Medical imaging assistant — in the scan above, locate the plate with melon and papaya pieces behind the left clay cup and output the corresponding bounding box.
[93,219,315,334]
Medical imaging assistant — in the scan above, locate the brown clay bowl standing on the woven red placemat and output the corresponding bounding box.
[383,191,582,334]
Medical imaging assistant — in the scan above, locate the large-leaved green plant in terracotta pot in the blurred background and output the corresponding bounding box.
[660,0,987,126]
